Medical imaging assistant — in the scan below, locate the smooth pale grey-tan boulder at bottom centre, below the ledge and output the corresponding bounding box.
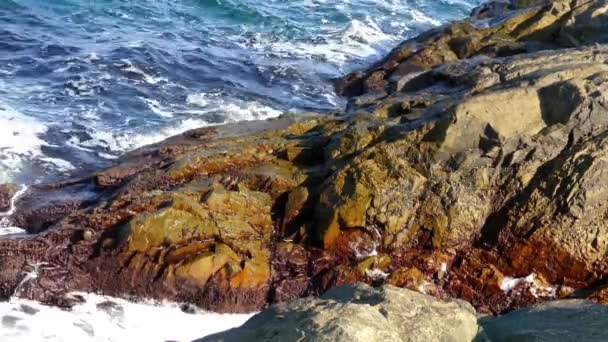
[198,284,478,342]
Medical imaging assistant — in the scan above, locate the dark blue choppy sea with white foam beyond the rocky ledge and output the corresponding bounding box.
[0,0,481,183]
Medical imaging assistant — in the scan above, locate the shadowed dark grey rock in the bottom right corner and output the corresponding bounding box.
[477,300,608,342]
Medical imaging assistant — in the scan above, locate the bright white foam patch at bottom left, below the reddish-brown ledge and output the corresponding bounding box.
[0,293,252,342]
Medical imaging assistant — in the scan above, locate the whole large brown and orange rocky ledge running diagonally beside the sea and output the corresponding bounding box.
[0,0,608,313]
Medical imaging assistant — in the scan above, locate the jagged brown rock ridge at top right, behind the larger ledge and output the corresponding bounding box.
[336,0,608,99]
